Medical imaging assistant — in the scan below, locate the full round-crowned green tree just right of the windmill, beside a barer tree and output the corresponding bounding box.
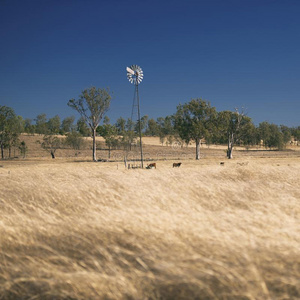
[174,99,217,160]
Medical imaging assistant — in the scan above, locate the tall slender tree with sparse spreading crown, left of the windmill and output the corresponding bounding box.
[68,87,111,161]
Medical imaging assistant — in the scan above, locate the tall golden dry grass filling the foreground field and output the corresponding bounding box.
[0,158,300,300]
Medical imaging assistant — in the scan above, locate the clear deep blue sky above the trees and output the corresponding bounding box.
[0,0,300,126]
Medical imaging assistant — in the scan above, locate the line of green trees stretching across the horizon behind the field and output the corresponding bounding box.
[0,99,300,159]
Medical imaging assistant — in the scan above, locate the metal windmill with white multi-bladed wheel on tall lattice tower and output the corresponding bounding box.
[126,65,144,168]
